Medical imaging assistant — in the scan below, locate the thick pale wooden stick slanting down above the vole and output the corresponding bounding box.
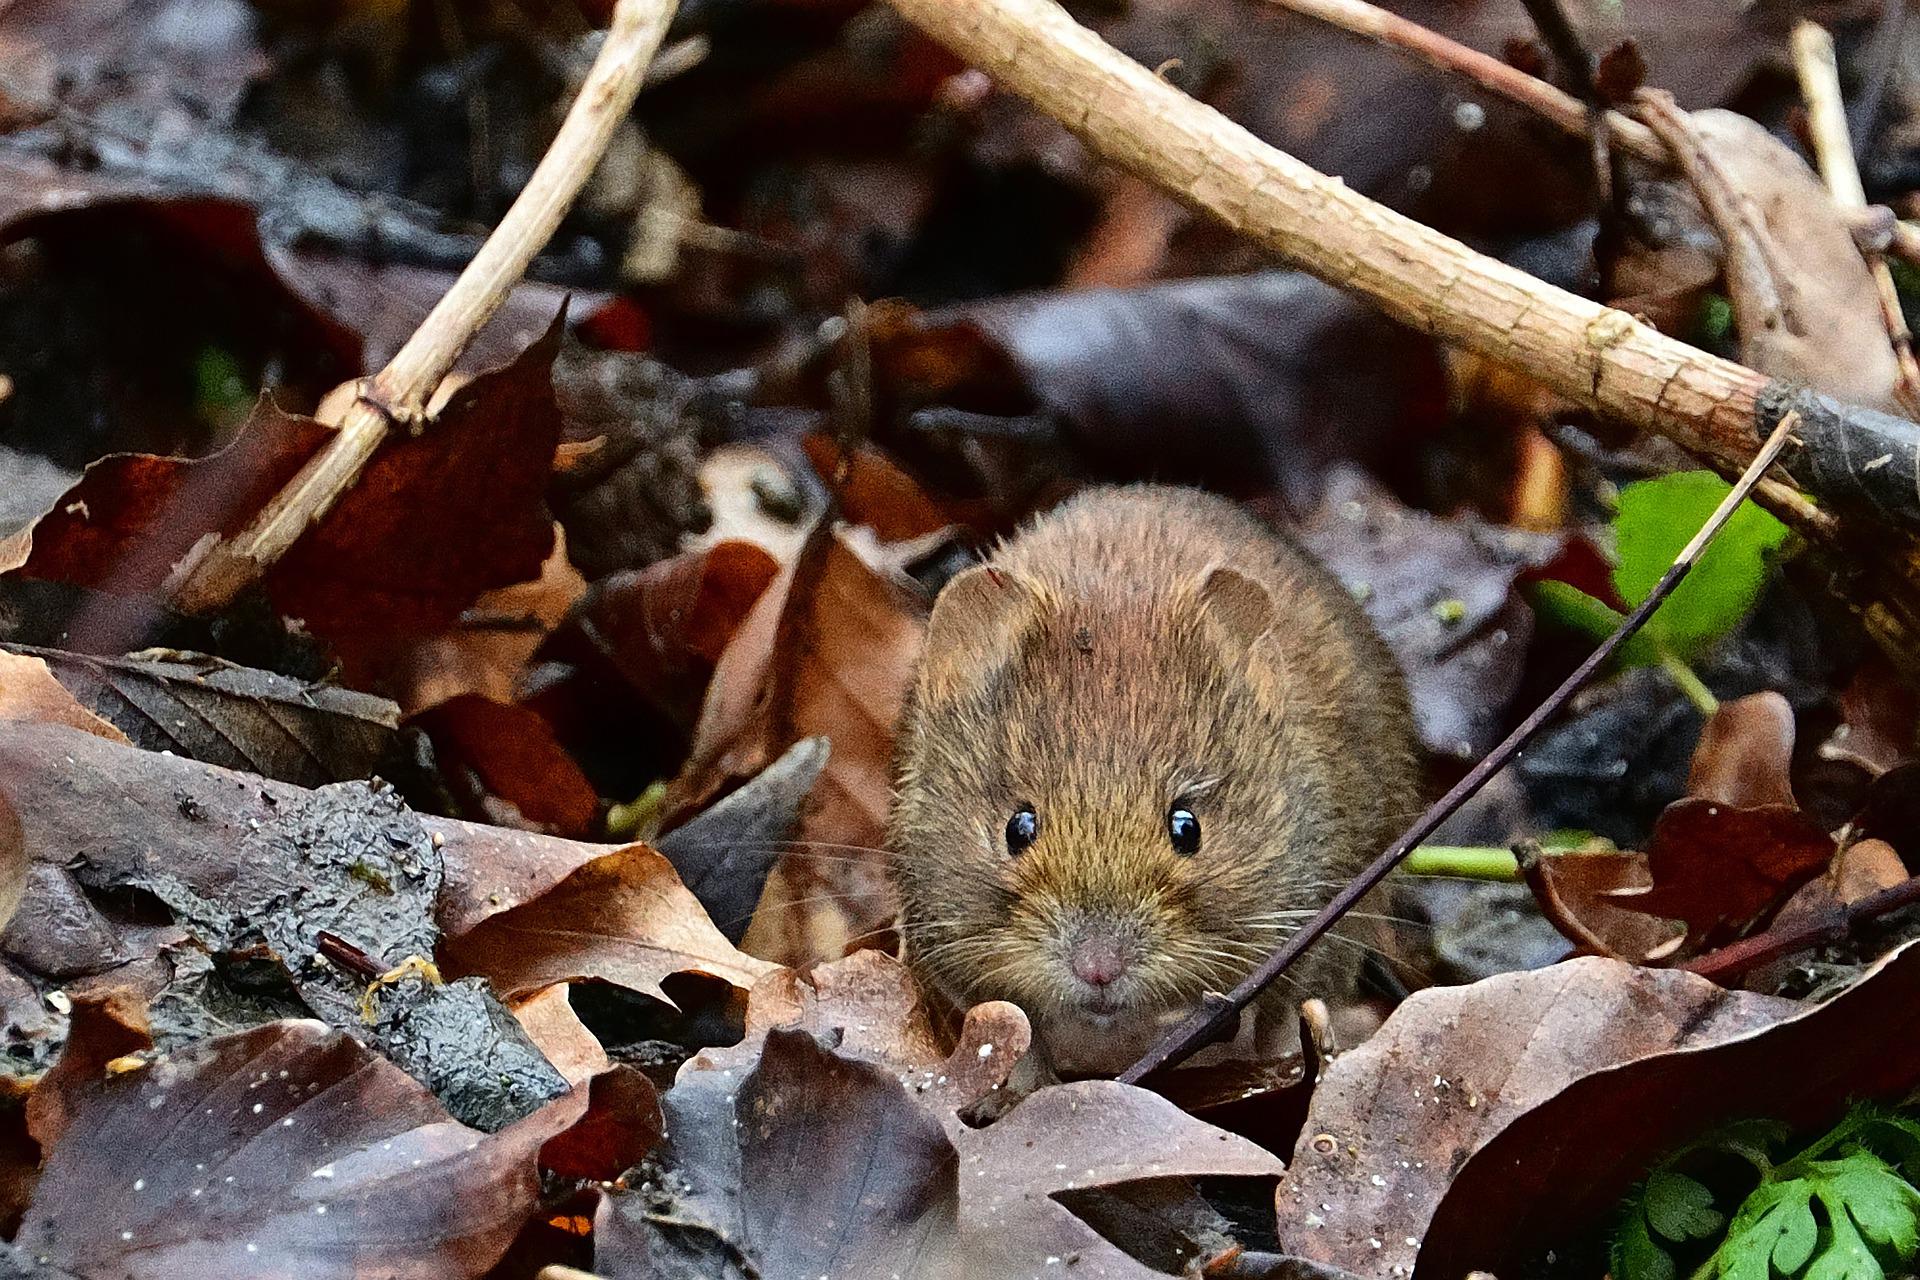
[891,0,1778,470]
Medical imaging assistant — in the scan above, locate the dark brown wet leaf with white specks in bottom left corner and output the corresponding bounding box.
[15,1023,582,1278]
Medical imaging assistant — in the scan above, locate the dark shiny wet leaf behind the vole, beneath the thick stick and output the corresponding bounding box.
[964,271,1444,509]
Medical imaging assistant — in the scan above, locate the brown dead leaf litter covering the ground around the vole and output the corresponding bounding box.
[0,0,1920,1280]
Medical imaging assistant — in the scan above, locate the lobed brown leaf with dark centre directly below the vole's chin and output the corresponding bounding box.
[593,952,1279,1280]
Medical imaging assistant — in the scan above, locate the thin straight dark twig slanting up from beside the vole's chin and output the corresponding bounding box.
[1119,413,1799,1084]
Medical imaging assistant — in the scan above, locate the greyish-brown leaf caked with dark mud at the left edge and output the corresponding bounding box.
[0,725,614,1126]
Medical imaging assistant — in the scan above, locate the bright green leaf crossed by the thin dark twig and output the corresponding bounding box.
[1596,470,1788,660]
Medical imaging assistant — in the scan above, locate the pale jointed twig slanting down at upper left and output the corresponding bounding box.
[171,0,676,612]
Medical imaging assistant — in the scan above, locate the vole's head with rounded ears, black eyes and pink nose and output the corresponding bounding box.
[893,568,1332,1071]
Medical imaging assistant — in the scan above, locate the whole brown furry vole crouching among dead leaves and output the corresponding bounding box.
[889,486,1417,1073]
